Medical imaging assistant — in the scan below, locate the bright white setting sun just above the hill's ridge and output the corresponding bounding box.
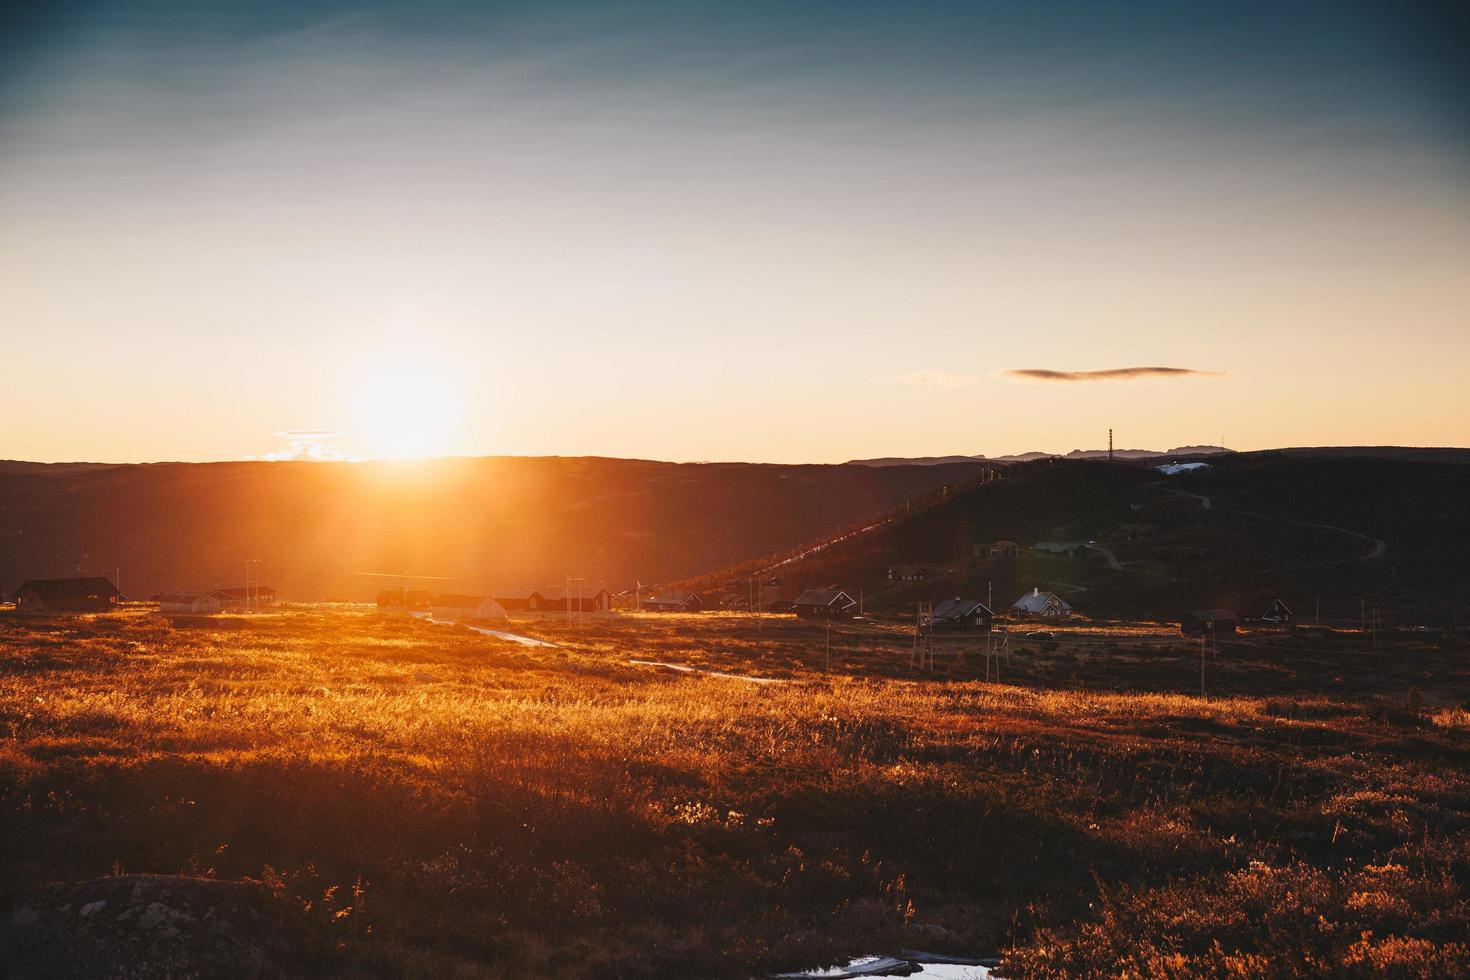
[353,341,465,460]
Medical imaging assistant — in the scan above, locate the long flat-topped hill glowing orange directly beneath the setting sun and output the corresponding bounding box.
[0,457,986,599]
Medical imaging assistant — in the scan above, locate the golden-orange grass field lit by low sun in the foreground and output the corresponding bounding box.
[0,607,1470,977]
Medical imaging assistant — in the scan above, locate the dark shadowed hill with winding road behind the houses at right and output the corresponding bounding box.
[691,453,1470,624]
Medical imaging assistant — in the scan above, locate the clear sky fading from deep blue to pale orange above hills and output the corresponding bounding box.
[0,0,1470,463]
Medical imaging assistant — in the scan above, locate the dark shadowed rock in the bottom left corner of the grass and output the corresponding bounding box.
[0,874,293,980]
